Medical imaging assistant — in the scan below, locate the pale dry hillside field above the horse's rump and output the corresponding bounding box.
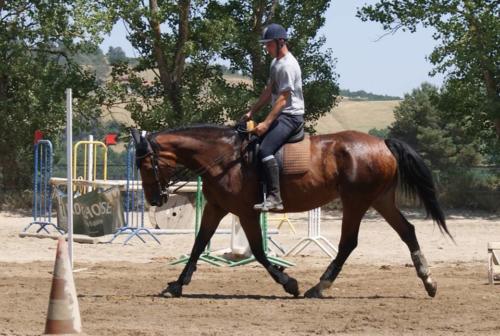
[316,99,400,134]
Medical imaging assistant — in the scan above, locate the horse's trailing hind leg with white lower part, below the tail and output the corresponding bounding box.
[373,190,437,297]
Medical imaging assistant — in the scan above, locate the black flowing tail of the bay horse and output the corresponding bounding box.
[385,139,453,239]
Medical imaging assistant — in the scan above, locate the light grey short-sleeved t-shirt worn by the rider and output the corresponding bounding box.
[269,52,304,115]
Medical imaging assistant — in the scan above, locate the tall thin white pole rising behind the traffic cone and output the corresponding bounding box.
[66,89,73,268]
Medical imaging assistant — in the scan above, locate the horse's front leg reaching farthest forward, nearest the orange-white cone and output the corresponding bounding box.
[161,203,227,297]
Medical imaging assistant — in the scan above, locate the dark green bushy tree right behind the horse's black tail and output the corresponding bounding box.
[388,84,500,211]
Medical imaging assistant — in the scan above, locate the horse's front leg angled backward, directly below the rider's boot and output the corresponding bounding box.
[240,212,299,297]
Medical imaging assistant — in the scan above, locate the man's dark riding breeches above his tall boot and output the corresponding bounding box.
[259,113,304,160]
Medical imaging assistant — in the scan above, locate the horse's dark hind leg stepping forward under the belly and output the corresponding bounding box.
[304,197,369,298]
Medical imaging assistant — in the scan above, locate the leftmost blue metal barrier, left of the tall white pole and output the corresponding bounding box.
[22,140,64,234]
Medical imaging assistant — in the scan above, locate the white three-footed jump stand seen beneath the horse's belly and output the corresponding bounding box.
[285,208,338,259]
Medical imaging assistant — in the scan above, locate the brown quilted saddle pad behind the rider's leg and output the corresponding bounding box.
[283,136,311,174]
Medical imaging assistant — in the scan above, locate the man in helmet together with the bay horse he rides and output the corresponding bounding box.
[131,25,451,298]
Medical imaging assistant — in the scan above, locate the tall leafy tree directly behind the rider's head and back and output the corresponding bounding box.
[209,0,338,127]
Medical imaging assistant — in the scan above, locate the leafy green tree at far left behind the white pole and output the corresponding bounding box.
[0,0,109,189]
